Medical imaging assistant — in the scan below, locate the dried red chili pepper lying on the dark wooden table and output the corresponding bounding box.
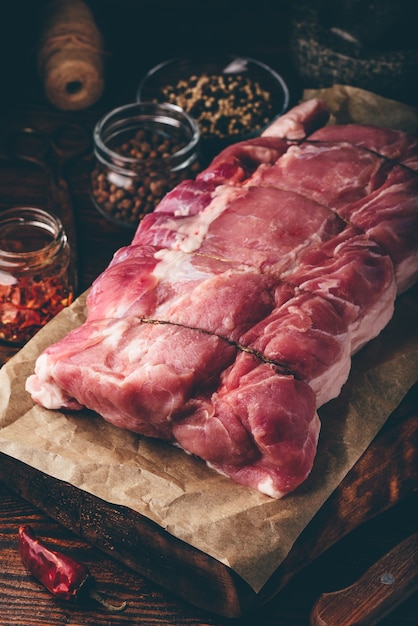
[18,524,126,611]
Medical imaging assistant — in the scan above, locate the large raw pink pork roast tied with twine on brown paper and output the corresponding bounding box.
[27,99,418,498]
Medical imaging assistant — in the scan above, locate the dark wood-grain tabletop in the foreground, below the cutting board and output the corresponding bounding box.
[0,484,418,626]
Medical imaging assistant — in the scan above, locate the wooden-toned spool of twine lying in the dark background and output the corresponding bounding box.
[37,0,104,110]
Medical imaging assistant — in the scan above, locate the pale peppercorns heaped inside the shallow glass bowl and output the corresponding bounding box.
[157,74,273,138]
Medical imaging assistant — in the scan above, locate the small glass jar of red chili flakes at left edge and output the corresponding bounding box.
[0,207,75,346]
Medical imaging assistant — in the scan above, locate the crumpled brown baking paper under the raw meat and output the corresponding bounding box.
[0,88,418,592]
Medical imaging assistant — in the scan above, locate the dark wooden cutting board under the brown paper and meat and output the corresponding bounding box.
[0,383,418,617]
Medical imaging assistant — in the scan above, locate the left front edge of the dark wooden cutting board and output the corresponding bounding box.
[0,453,257,618]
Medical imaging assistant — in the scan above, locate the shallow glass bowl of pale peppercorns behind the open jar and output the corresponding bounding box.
[137,53,289,157]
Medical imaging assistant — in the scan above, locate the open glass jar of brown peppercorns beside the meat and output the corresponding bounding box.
[91,102,200,229]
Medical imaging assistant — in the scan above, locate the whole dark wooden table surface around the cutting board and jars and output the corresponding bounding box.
[0,0,418,626]
